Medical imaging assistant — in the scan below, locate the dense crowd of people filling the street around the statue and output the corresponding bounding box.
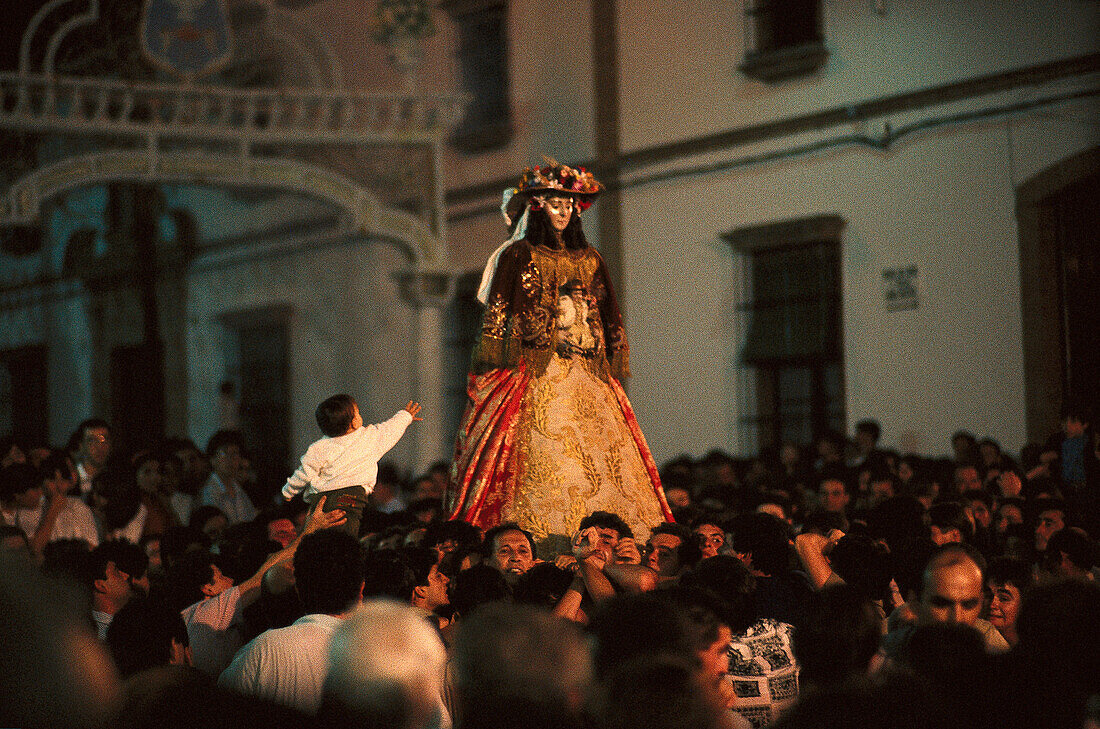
[0,411,1100,729]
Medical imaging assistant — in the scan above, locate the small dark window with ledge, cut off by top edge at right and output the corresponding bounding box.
[740,0,828,82]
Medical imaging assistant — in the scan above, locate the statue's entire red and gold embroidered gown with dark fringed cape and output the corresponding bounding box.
[447,240,672,540]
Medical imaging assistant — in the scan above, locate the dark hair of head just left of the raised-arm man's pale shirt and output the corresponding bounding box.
[107,598,189,678]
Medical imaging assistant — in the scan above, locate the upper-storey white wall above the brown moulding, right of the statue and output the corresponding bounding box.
[618,0,1100,150]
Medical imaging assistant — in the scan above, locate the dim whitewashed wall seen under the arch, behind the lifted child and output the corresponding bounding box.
[188,232,418,467]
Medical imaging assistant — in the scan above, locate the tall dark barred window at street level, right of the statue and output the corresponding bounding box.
[726,216,845,449]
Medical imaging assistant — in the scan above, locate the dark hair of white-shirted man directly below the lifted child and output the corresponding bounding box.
[294,529,363,615]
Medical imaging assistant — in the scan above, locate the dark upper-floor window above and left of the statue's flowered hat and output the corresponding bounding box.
[440,0,512,152]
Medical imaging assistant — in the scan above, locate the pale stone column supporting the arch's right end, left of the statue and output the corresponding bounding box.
[397,270,454,473]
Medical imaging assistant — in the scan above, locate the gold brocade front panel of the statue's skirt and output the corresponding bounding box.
[503,354,664,540]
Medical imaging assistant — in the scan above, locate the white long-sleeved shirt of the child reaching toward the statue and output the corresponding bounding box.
[283,410,413,500]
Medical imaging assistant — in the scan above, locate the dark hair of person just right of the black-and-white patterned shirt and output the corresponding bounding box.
[792,585,882,686]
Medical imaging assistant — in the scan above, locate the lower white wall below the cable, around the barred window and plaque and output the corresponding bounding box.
[625,92,1100,461]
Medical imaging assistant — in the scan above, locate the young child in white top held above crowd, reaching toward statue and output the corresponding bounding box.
[283,395,422,539]
